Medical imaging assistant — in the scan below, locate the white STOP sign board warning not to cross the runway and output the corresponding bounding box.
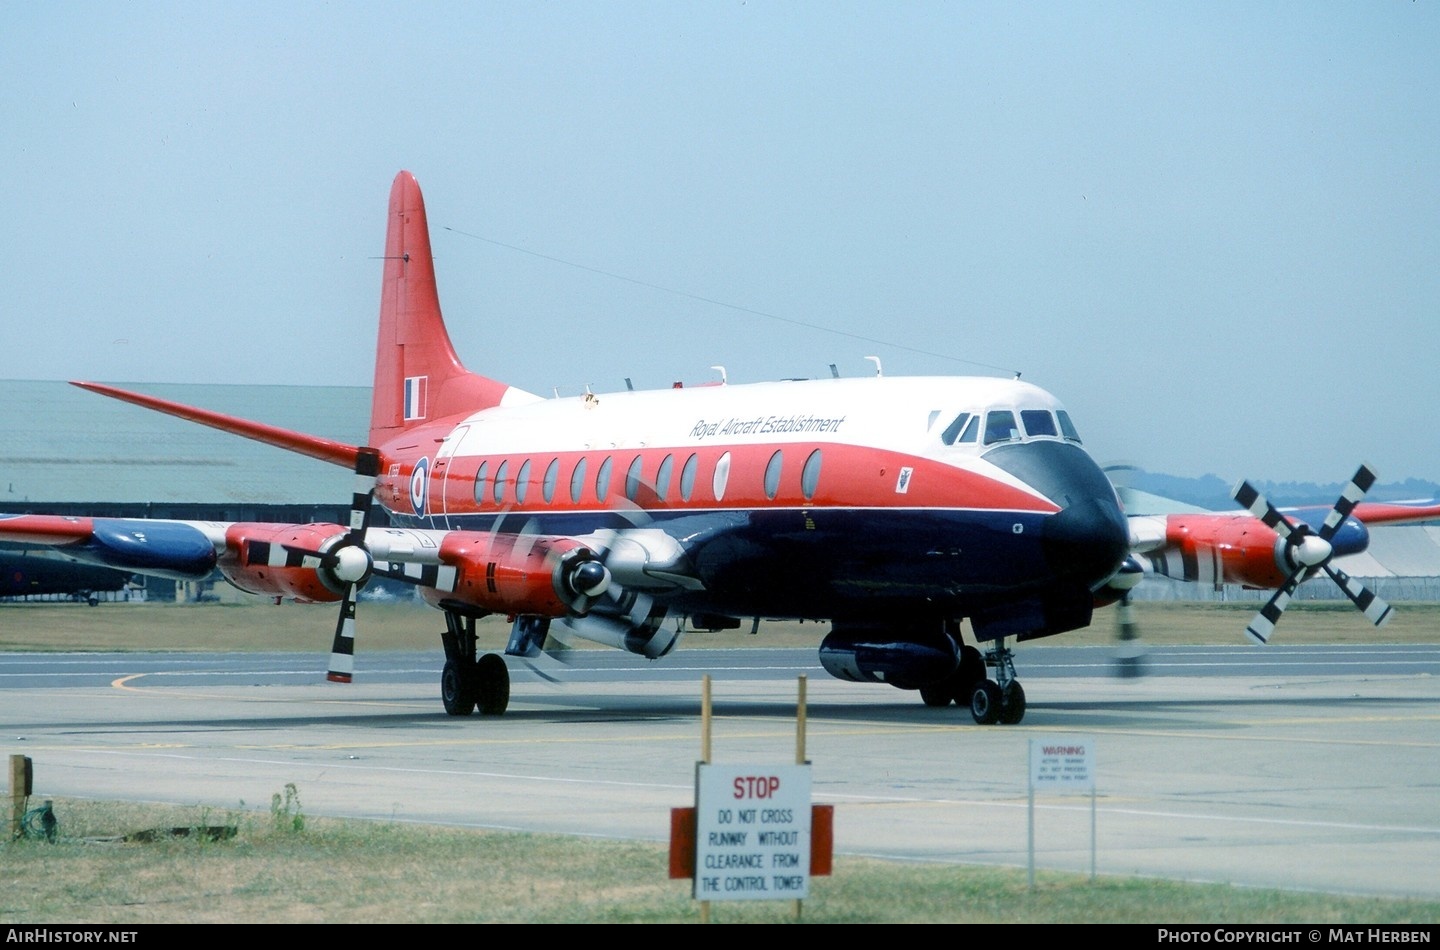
[694,763,811,901]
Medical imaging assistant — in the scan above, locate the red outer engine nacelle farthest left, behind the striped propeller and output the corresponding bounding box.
[217,523,354,603]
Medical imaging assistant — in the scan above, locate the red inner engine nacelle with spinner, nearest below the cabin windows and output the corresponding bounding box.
[426,533,609,618]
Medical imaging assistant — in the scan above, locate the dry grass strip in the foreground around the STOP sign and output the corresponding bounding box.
[0,789,1440,926]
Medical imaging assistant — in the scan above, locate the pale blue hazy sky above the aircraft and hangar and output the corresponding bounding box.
[0,0,1440,482]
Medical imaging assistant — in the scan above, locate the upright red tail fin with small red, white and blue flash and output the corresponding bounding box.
[370,171,520,445]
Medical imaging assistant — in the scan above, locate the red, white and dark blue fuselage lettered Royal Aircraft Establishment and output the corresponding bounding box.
[376,377,1128,636]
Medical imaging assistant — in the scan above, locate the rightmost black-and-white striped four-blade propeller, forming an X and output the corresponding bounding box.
[1231,465,1390,643]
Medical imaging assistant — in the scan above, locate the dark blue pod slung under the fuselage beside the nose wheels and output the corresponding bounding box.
[819,626,960,689]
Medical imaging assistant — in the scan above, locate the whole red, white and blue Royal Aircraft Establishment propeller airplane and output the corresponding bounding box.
[0,171,1440,724]
